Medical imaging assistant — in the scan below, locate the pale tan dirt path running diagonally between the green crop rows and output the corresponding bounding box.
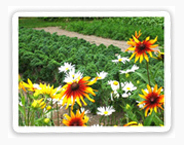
[35,27,129,51]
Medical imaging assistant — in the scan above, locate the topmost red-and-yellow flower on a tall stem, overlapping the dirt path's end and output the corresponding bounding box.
[125,36,158,63]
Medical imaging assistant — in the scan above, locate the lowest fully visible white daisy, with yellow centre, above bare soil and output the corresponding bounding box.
[97,106,115,116]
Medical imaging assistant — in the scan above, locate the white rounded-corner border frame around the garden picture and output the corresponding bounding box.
[12,10,171,133]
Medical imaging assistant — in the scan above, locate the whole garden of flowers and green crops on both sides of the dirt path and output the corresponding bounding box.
[19,17,164,127]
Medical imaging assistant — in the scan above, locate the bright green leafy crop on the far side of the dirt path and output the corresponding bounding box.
[61,17,164,45]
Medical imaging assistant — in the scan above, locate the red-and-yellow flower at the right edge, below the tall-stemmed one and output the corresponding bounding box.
[138,85,164,116]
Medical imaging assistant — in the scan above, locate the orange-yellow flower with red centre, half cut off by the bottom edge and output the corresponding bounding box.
[62,110,89,126]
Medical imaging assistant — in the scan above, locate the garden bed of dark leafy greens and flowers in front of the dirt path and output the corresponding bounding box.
[19,17,164,126]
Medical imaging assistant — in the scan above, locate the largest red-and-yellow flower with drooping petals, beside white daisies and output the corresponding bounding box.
[59,76,97,109]
